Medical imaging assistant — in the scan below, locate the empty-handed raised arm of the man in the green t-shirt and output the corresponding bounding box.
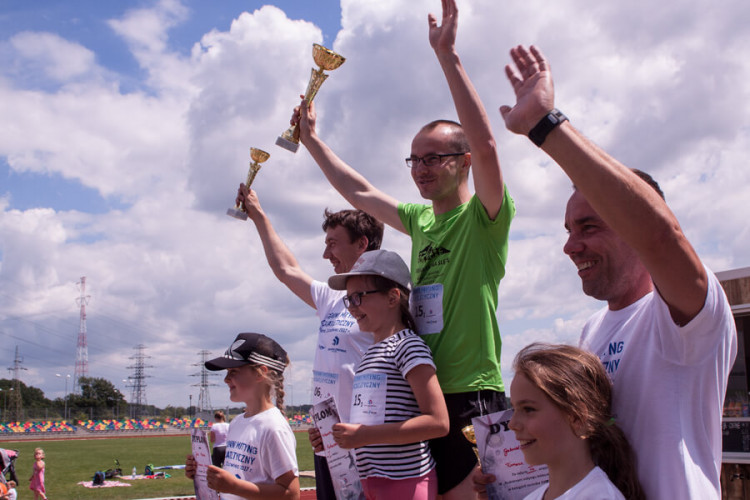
[427,0,503,219]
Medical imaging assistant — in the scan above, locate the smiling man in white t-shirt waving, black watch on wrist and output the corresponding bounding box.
[490,46,737,500]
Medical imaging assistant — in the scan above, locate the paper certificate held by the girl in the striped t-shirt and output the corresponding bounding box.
[312,398,365,500]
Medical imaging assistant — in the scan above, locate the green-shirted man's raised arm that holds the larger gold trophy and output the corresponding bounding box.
[292,100,406,233]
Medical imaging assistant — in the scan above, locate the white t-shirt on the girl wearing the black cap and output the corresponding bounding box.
[221,406,299,500]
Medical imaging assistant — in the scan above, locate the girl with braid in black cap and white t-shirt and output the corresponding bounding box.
[185,333,299,500]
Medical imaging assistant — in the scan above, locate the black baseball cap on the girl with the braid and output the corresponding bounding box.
[206,333,289,373]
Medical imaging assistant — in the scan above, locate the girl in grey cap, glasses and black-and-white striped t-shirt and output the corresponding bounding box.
[328,250,448,500]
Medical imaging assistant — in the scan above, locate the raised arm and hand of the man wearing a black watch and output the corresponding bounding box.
[500,46,708,324]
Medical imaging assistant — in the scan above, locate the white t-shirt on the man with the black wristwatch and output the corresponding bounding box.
[580,270,737,500]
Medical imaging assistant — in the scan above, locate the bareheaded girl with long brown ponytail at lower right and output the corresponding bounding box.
[509,343,645,500]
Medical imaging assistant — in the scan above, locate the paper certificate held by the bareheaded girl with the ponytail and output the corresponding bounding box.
[471,410,549,500]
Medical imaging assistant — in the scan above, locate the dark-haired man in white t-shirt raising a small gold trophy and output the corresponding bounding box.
[237,184,383,500]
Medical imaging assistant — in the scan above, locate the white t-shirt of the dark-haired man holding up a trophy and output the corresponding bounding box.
[310,281,374,424]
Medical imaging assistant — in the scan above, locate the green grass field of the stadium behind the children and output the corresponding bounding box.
[0,432,315,500]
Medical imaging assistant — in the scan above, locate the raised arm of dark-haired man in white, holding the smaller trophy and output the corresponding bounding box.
[237,184,315,308]
